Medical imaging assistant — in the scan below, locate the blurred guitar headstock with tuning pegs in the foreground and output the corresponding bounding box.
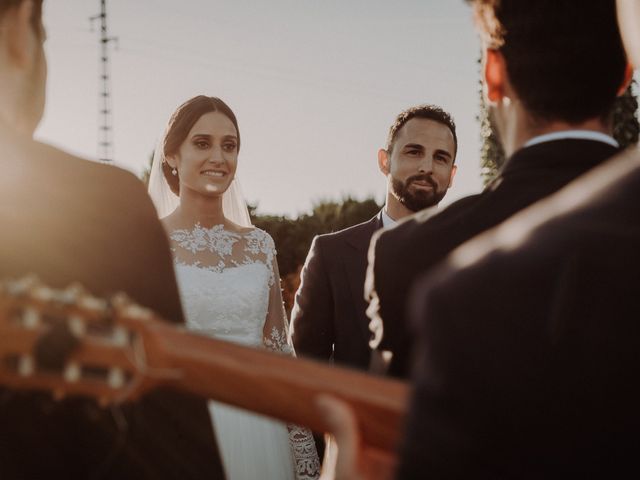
[0,277,170,406]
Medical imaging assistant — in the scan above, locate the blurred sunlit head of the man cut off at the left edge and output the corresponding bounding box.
[0,0,47,135]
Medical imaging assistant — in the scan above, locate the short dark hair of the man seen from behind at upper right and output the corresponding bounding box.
[467,0,627,124]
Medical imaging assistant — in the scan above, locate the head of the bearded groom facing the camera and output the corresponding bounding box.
[378,105,458,220]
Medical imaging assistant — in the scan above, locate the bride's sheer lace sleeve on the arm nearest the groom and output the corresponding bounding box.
[263,240,320,480]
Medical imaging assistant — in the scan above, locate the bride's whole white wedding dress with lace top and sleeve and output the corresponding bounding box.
[169,225,320,480]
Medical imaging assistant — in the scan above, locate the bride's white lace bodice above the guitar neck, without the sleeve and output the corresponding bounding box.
[169,225,275,347]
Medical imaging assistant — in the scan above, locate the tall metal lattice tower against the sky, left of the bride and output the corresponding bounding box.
[89,0,118,163]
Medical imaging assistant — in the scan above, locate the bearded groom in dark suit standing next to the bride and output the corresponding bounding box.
[291,105,458,370]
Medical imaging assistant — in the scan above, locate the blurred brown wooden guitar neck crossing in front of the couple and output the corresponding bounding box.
[147,325,409,451]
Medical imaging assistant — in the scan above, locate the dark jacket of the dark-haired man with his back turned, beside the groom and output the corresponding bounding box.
[367,139,618,377]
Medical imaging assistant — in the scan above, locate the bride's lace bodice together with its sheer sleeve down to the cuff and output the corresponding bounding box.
[169,225,320,480]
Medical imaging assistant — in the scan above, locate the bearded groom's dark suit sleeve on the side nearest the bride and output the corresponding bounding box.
[291,237,335,360]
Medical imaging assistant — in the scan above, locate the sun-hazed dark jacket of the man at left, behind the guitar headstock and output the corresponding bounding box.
[0,132,223,480]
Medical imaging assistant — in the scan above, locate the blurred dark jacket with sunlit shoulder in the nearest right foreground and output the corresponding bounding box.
[398,151,640,479]
